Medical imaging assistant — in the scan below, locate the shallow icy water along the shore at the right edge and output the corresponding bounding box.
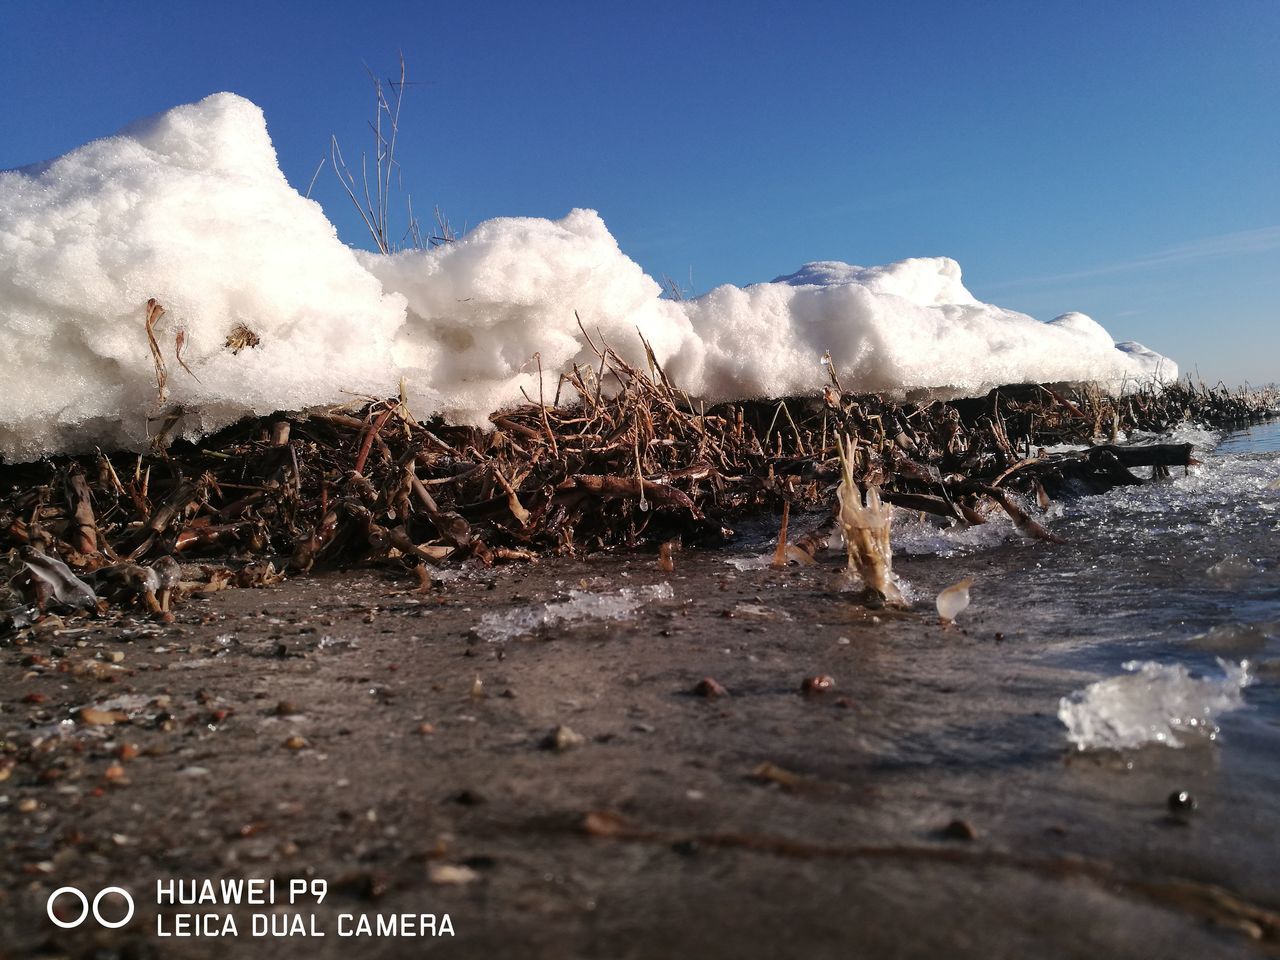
[875,421,1280,896]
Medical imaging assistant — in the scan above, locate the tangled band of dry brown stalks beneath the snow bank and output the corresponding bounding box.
[0,343,1272,630]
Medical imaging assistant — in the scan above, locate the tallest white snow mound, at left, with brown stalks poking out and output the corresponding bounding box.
[0,93,404,461]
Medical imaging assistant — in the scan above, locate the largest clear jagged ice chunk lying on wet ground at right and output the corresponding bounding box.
[1057,659,1249,750]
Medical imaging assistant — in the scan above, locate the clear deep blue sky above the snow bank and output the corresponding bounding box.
[0,0,1280,383]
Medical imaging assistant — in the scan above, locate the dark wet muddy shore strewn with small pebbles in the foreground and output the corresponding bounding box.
[0,543,1280,959]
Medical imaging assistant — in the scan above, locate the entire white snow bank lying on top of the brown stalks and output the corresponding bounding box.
[0,93,1176,461]
